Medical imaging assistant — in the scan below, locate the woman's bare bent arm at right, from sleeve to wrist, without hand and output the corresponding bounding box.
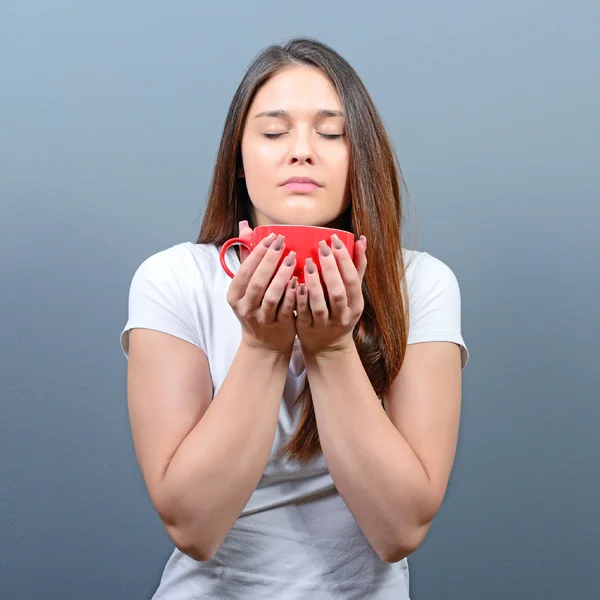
[307,342,461,562]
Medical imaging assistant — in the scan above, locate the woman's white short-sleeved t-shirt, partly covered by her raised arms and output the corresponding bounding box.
[121,242,469,600]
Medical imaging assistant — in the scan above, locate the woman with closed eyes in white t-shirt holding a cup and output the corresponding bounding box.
[122,39,468,600]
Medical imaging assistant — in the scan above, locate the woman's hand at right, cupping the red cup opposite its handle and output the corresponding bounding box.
[296,235,367,357]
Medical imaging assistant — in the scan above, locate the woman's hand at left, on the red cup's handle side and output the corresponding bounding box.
[227,223,298,356]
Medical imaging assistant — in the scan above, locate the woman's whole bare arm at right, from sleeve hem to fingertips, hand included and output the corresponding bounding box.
[297,238,462,562]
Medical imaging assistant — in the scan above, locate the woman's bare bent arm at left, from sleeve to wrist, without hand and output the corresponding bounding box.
[128,329,289,560]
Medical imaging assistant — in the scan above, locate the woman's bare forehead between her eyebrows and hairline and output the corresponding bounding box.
[250,66,342,116]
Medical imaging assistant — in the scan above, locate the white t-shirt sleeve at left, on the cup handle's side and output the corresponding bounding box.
[120,247,206,357]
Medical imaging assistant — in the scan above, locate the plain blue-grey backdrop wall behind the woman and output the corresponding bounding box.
[0,0,600,600]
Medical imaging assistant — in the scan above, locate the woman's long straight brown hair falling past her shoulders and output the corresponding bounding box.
[197,38,408,462]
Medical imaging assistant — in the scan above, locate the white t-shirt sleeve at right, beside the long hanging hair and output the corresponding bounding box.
[407,252,469,369]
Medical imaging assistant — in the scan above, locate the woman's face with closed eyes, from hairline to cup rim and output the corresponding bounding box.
[242,66,350,226]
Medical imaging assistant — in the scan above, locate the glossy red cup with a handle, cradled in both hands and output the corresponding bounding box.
[220,225,354,283]
